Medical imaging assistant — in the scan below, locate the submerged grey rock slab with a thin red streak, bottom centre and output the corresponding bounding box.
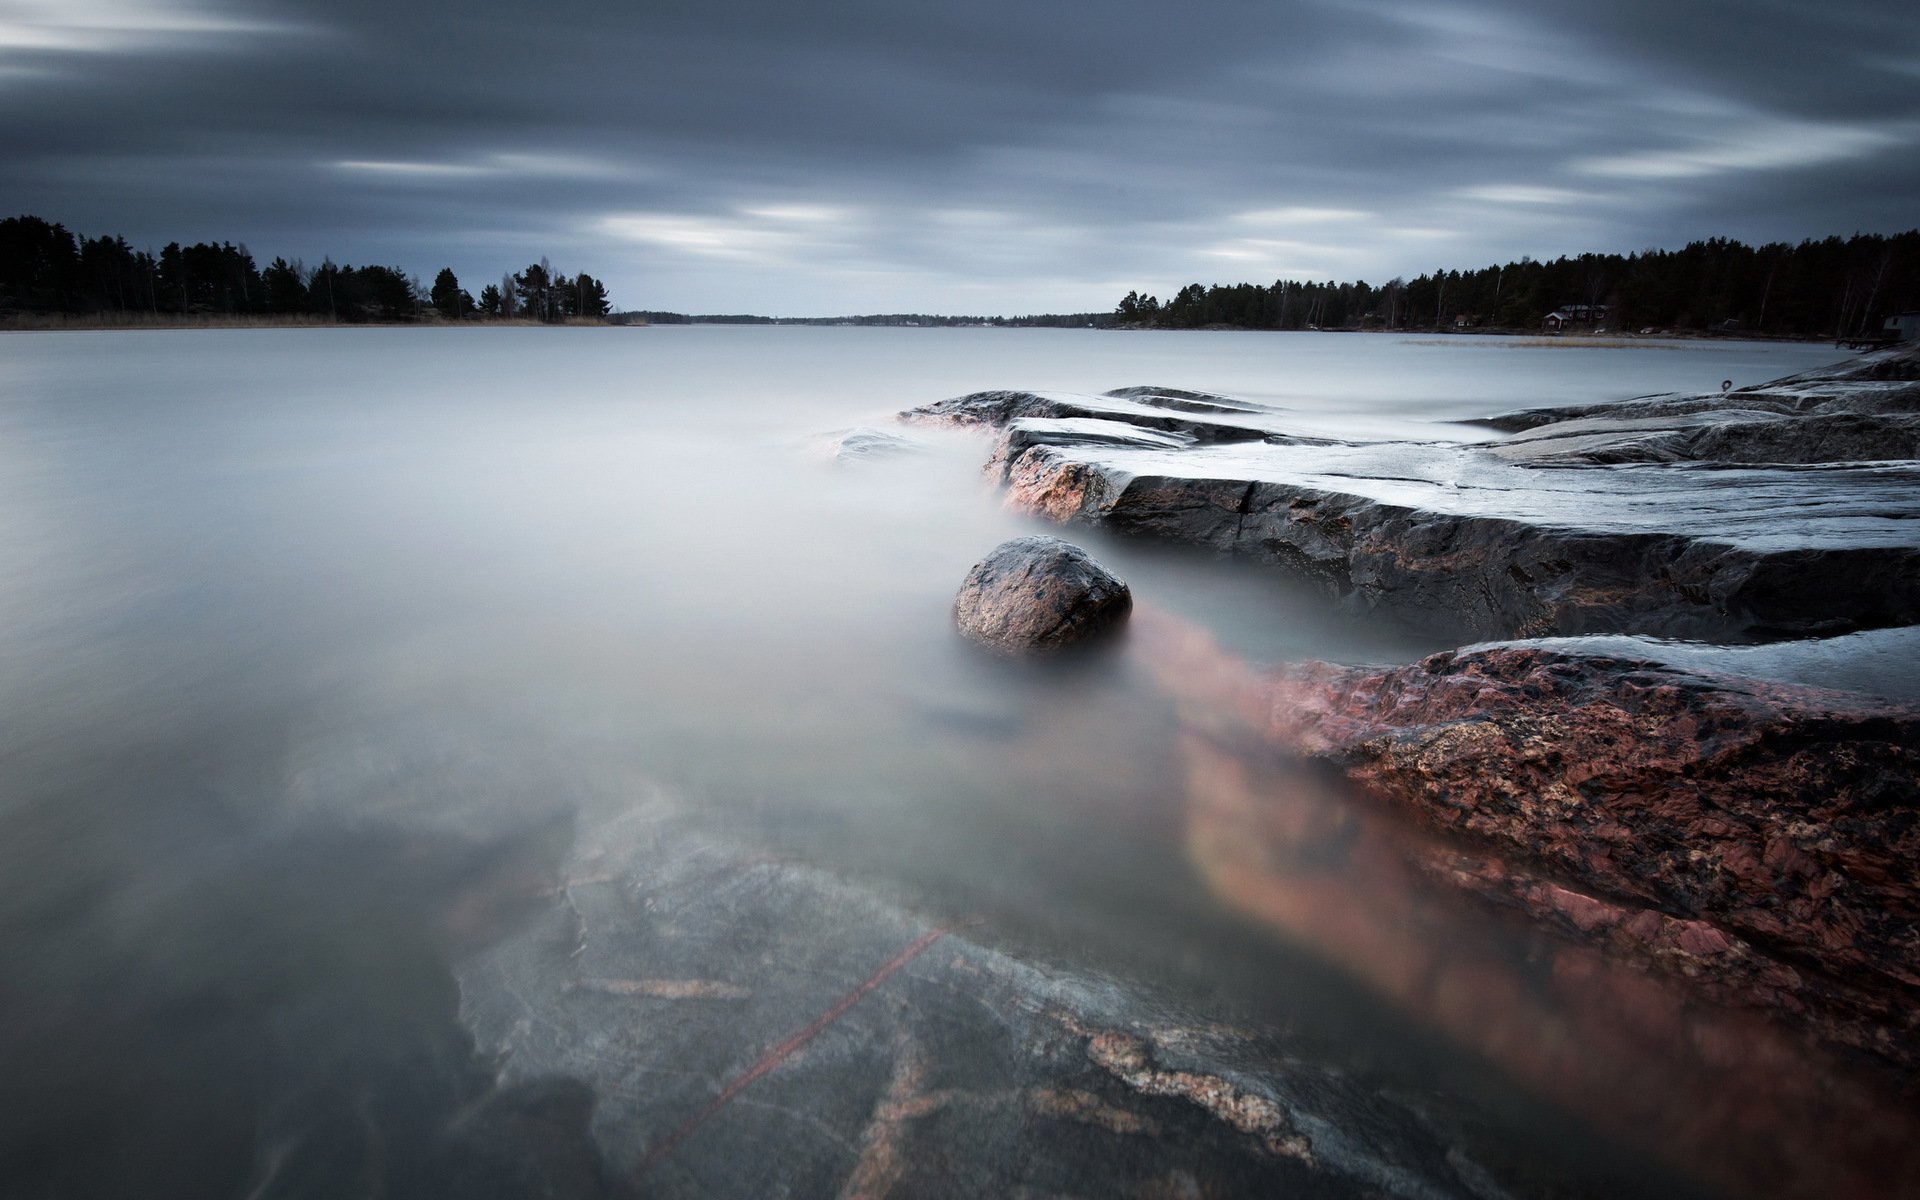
[461,817,1543,1200]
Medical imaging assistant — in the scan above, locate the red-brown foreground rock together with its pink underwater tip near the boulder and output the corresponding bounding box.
[1137,614,1920,1081]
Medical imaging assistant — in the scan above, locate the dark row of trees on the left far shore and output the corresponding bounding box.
[0,217,612,323]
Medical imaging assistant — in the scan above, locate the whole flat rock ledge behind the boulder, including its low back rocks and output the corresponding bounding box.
[906,351,1920,641]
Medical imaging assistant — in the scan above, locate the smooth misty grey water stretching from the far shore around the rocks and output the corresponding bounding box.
[0,328,1858,1194]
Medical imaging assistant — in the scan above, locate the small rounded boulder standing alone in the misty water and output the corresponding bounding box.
[954,538,1133,655]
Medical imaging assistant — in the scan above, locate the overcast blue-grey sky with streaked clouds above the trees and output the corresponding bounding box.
[0,0,1920,315]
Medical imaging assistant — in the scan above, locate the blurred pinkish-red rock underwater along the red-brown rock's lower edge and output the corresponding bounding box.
[1144,614,1920,1196]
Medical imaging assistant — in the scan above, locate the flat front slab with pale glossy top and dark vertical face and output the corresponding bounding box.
[1006,445,1920,641]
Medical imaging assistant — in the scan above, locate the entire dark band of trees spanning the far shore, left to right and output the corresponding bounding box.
[0,215,1920,342]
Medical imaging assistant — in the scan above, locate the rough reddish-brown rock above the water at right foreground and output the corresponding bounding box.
[1327,645,1920,1013]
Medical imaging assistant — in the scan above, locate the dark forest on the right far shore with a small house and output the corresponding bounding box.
[1114,230,1920,338]
